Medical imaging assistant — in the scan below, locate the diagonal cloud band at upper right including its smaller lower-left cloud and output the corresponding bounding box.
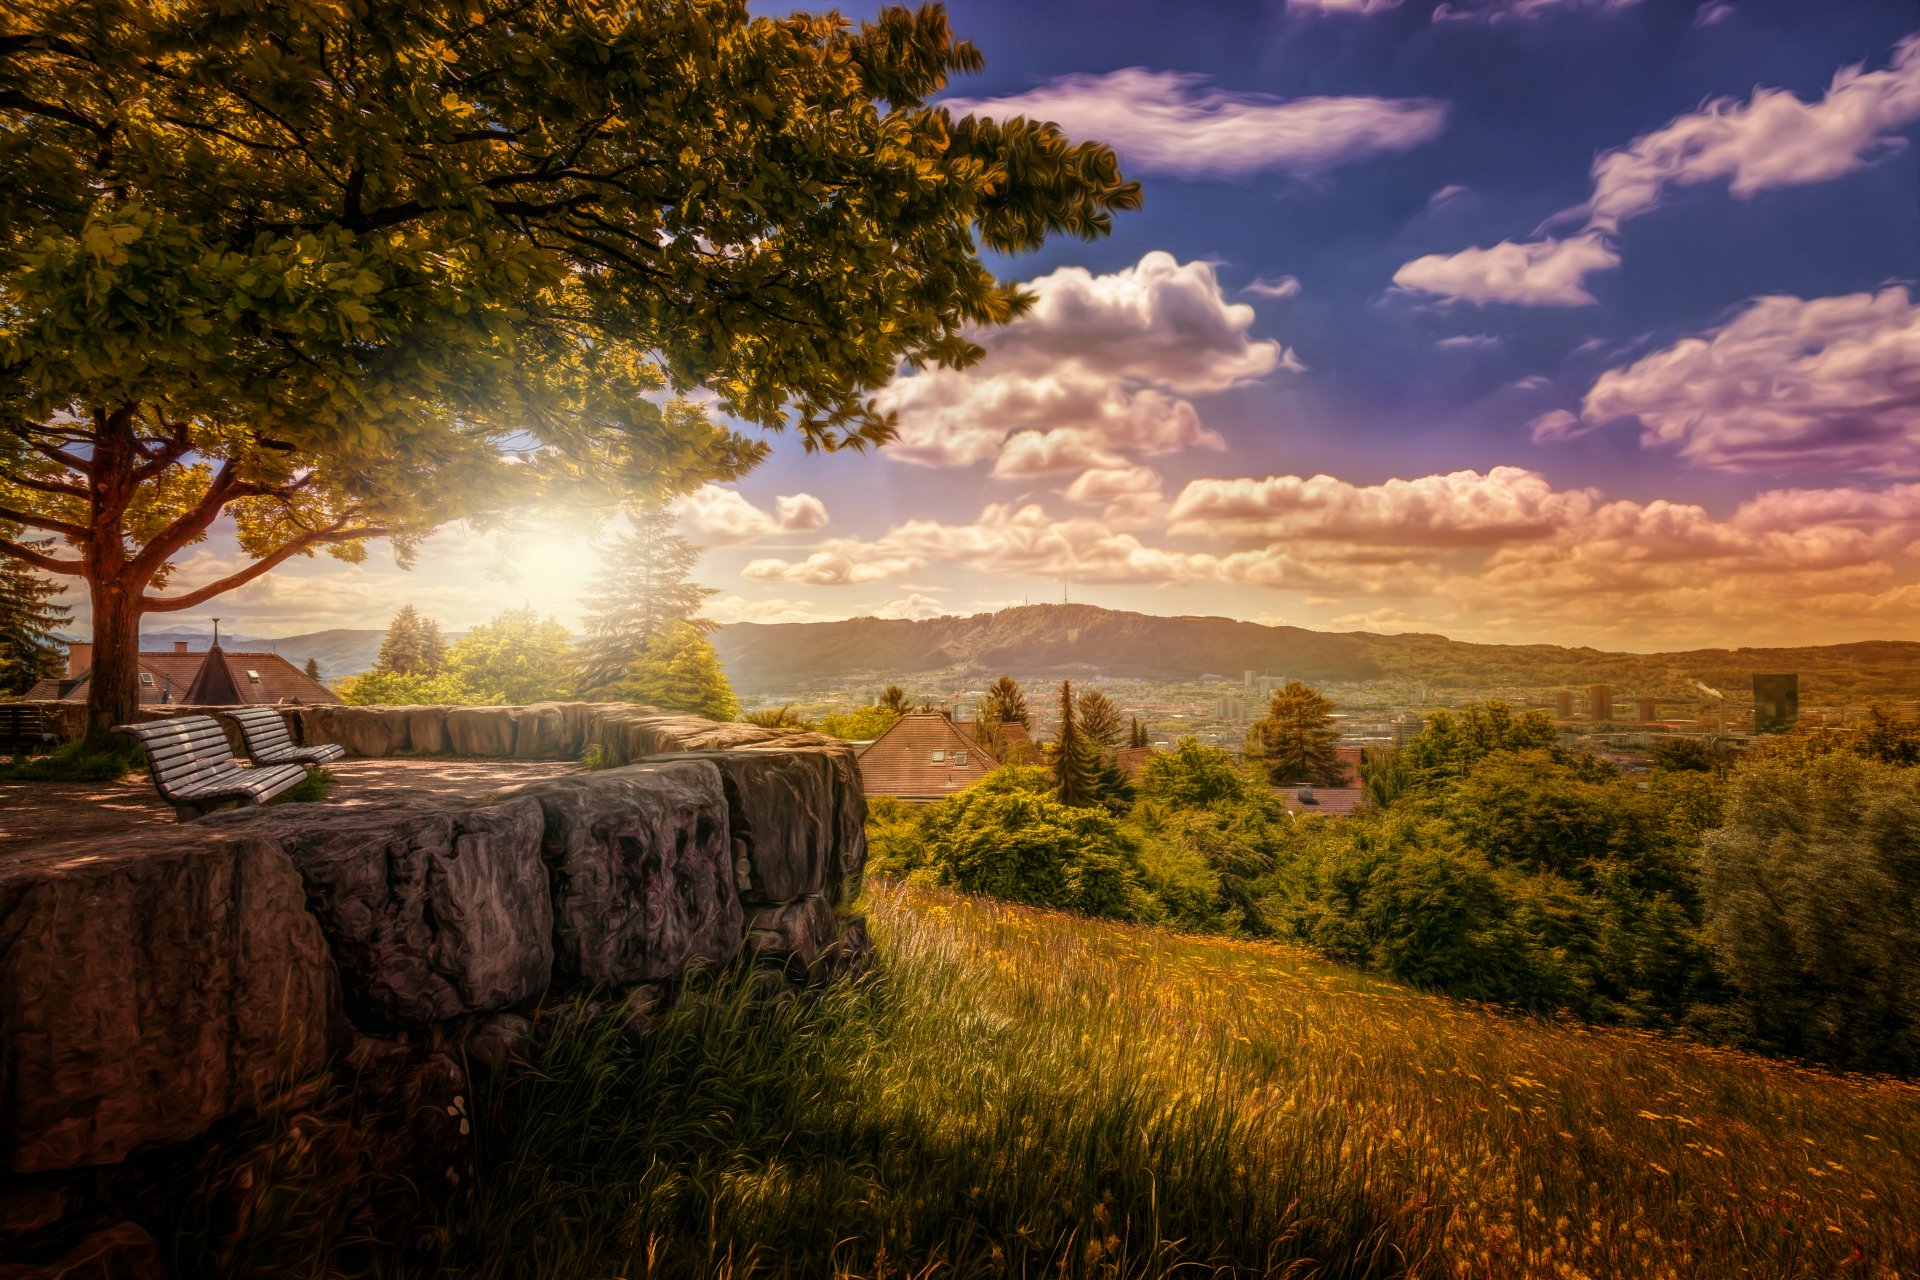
[1394,35,1920,307]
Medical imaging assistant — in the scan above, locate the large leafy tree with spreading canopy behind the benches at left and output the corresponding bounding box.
[0,0,1139,739]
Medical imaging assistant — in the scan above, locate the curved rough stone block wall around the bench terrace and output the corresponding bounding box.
[0,704,866,1274]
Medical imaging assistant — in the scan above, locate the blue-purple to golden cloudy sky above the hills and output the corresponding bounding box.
[120,0,1920,651]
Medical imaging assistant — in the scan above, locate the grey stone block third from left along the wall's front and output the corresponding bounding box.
[511,760,741,986]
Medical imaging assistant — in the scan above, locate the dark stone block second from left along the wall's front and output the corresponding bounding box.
[205,798,553,1027]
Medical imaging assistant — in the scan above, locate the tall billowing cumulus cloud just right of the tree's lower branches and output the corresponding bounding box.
[877,251,1286,478]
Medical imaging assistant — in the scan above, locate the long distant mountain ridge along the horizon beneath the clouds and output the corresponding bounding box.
[714,604,1920,700]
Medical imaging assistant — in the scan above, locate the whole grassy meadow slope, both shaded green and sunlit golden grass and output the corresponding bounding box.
[411,885,1920,1280]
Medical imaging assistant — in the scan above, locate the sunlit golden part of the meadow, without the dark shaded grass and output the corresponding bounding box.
[868,883,1920,1280]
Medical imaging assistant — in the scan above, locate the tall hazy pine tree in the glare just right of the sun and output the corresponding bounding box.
[578,503,714,695]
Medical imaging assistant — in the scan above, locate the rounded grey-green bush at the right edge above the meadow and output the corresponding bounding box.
[1701,752,1920,1073]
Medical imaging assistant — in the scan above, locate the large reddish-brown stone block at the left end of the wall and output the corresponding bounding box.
[0,827,344,1173]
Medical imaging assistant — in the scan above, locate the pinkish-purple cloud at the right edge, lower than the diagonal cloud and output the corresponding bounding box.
[1566,288,1920,476]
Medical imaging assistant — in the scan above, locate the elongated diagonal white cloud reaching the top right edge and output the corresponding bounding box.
[1586,36,1920,228]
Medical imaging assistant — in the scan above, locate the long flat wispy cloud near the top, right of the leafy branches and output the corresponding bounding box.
[945,68,1446,178]
